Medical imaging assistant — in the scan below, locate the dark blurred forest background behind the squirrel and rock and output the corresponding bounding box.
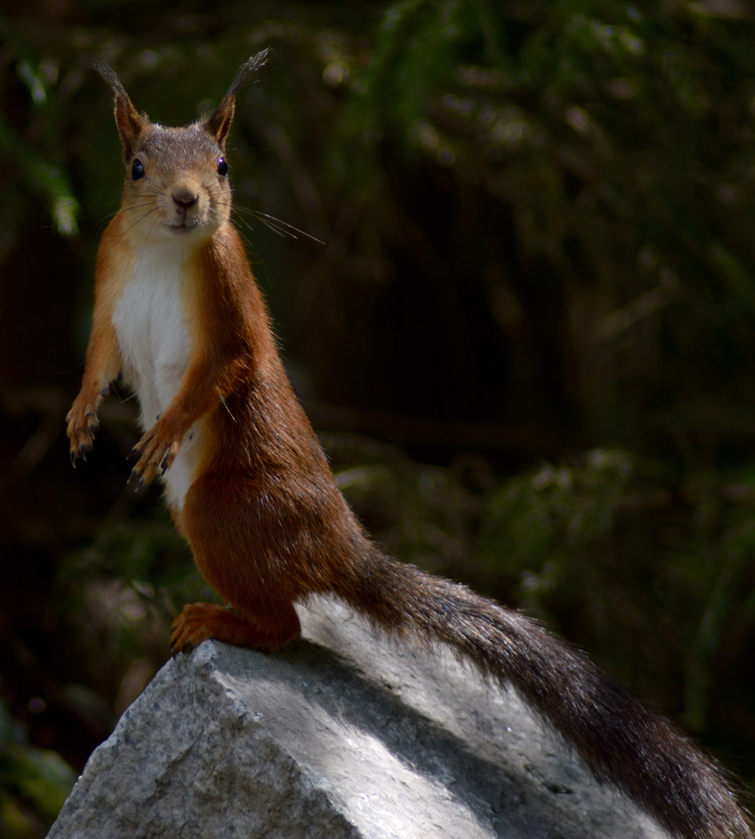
[0,0,755,839]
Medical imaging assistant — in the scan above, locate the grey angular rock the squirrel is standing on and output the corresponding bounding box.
[48,599,666,839]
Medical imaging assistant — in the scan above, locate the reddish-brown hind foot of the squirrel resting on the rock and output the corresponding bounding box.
[170,603,301,656]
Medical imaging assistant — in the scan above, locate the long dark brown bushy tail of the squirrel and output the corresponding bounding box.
[334,551,753,839]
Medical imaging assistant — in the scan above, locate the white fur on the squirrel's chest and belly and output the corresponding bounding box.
[113,242,201,510]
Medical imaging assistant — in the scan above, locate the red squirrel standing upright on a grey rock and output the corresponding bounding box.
[67,51,753,839]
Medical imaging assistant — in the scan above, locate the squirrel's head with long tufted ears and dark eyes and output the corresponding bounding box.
[92,50,268,241]
